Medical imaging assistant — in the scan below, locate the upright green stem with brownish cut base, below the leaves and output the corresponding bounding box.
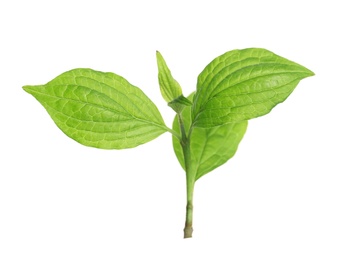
[178,114,195,238]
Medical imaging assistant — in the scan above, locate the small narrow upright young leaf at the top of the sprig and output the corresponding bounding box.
[156,51,182,103]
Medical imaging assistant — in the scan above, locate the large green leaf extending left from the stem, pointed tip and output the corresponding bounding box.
[23,69,168,149]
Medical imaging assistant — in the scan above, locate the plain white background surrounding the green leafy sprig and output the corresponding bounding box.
[0,0,344,260]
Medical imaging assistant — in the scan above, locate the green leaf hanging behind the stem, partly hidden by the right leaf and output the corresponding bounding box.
[173,94,247,179]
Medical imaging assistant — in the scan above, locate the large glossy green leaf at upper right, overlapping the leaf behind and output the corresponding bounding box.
[192,48,314,127]
